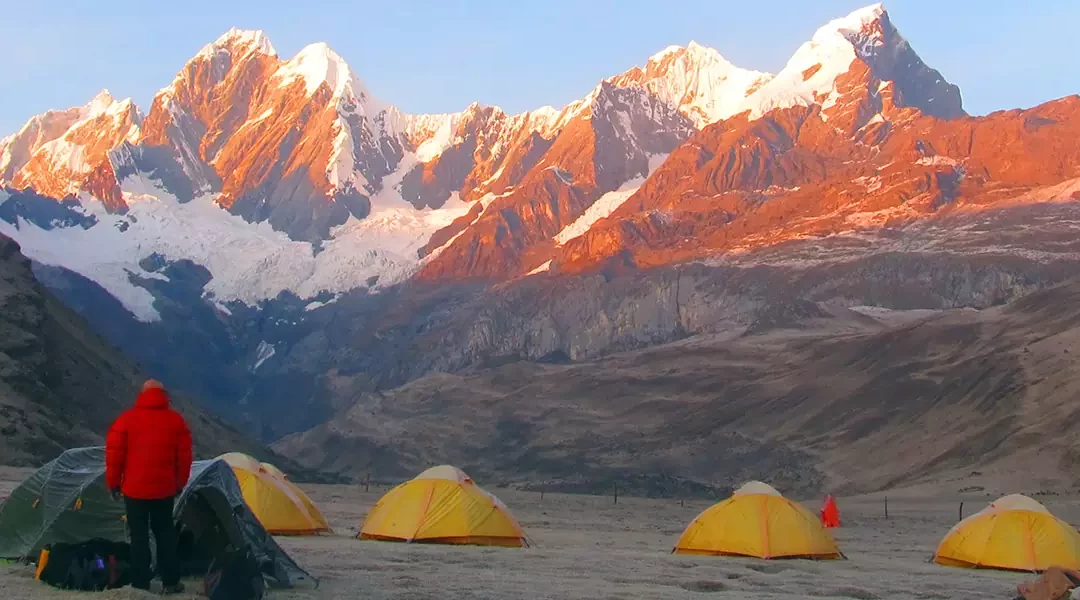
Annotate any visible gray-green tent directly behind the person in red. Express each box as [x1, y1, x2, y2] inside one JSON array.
[[0, 447, 316, 587]]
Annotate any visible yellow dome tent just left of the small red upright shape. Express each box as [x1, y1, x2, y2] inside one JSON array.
[[674, 481, 843, 559]]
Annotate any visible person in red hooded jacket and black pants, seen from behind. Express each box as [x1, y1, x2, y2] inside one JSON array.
[[105, 379, 191, 594]]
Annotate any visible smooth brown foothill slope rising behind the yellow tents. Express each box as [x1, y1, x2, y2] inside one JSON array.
[[275, 279, 1080, 497]]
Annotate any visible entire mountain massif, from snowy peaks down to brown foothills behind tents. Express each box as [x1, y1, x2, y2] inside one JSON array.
[[0, 4, 1080, 495]]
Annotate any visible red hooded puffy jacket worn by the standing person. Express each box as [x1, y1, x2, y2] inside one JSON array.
[[105, 387, 191, 500]]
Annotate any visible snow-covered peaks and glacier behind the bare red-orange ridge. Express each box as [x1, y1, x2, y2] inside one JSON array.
[[0, 4, 980, 321]]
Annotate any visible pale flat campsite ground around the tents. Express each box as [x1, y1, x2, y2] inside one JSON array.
[[0, 467, 1049, 600]]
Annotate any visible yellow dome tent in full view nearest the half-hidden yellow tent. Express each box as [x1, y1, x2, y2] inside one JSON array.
[[359, 465, 527, 547]]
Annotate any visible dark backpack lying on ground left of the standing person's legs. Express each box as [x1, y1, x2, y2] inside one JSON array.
[[38, 538, 131, 591]]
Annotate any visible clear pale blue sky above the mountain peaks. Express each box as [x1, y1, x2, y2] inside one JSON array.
[[0, 0, 1080, 135]]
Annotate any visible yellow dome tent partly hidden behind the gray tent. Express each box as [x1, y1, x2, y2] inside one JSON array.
[[220, 452, 330, 535]]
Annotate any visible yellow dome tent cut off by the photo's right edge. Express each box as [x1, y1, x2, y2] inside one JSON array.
[[934, 494, 1080, 571]]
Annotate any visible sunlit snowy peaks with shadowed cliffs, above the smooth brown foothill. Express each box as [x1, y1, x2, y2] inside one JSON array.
[[0, 5, 1080, 455]]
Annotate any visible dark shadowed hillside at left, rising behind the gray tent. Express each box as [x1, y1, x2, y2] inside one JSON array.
[[0, 232, 295, 470]]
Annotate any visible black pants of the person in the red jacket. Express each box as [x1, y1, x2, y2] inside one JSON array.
[[124, 496, 180, 589]]
